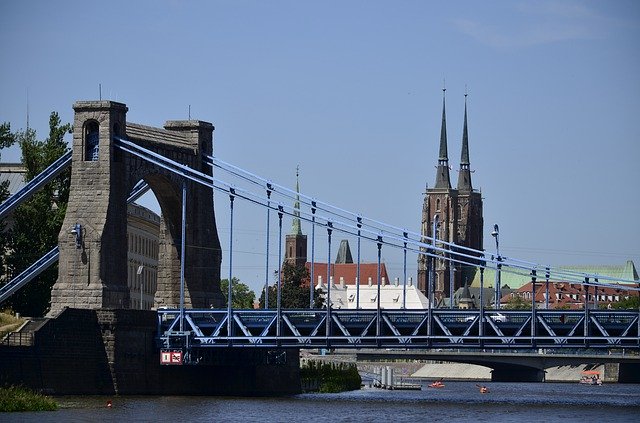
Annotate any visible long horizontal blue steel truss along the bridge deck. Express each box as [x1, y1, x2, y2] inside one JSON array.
[[158, 309, 640, 350]]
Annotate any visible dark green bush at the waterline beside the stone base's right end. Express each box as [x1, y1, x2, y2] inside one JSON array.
[[300, 360, 362, 393]]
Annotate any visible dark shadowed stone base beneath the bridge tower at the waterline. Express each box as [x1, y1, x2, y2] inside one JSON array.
[[0, 308, 301, 396]]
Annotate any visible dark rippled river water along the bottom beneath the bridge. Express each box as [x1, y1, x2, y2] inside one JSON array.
[[6, 382, 640, 423]]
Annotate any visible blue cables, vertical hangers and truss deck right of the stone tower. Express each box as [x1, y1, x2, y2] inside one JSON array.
[[6, 137, 640, 355]]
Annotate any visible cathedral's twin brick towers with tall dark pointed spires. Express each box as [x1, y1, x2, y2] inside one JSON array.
[[418, 89, 483, 305]]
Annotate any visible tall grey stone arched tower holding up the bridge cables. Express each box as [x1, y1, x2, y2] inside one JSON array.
[[49, 101, 224, 315]]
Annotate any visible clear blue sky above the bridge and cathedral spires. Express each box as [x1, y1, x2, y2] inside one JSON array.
[[0, 0, 640, 294]]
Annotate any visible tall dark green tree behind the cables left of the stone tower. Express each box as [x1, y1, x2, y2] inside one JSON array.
[[2, 112, 71, 317]]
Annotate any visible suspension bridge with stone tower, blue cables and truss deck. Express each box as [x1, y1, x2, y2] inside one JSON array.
[[0, 102, 640, 363]]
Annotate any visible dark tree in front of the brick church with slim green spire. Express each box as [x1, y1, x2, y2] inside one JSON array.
[[260, 262, 324, 308]]
